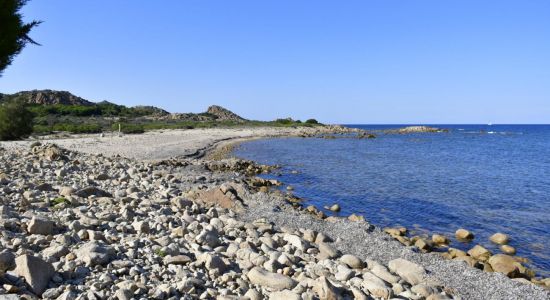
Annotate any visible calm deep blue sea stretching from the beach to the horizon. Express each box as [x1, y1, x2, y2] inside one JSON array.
[[236, 125, 550, 276]]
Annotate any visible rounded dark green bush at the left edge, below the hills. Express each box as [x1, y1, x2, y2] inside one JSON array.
[[0, 101, 33, 141]]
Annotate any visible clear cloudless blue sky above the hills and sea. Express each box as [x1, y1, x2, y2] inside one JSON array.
[[0, 0, 550, 123]]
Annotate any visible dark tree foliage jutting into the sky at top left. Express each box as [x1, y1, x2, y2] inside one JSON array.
[[0, 0, 41, 77]]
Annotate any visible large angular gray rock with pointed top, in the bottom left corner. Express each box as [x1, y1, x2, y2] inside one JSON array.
[[14, 254, 55, 295]]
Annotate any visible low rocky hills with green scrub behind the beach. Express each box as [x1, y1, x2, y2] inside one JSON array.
[[0, 90, 310, 134]]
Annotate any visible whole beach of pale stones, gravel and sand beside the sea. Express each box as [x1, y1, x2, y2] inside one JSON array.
[[0, 126, 550, 300]]
